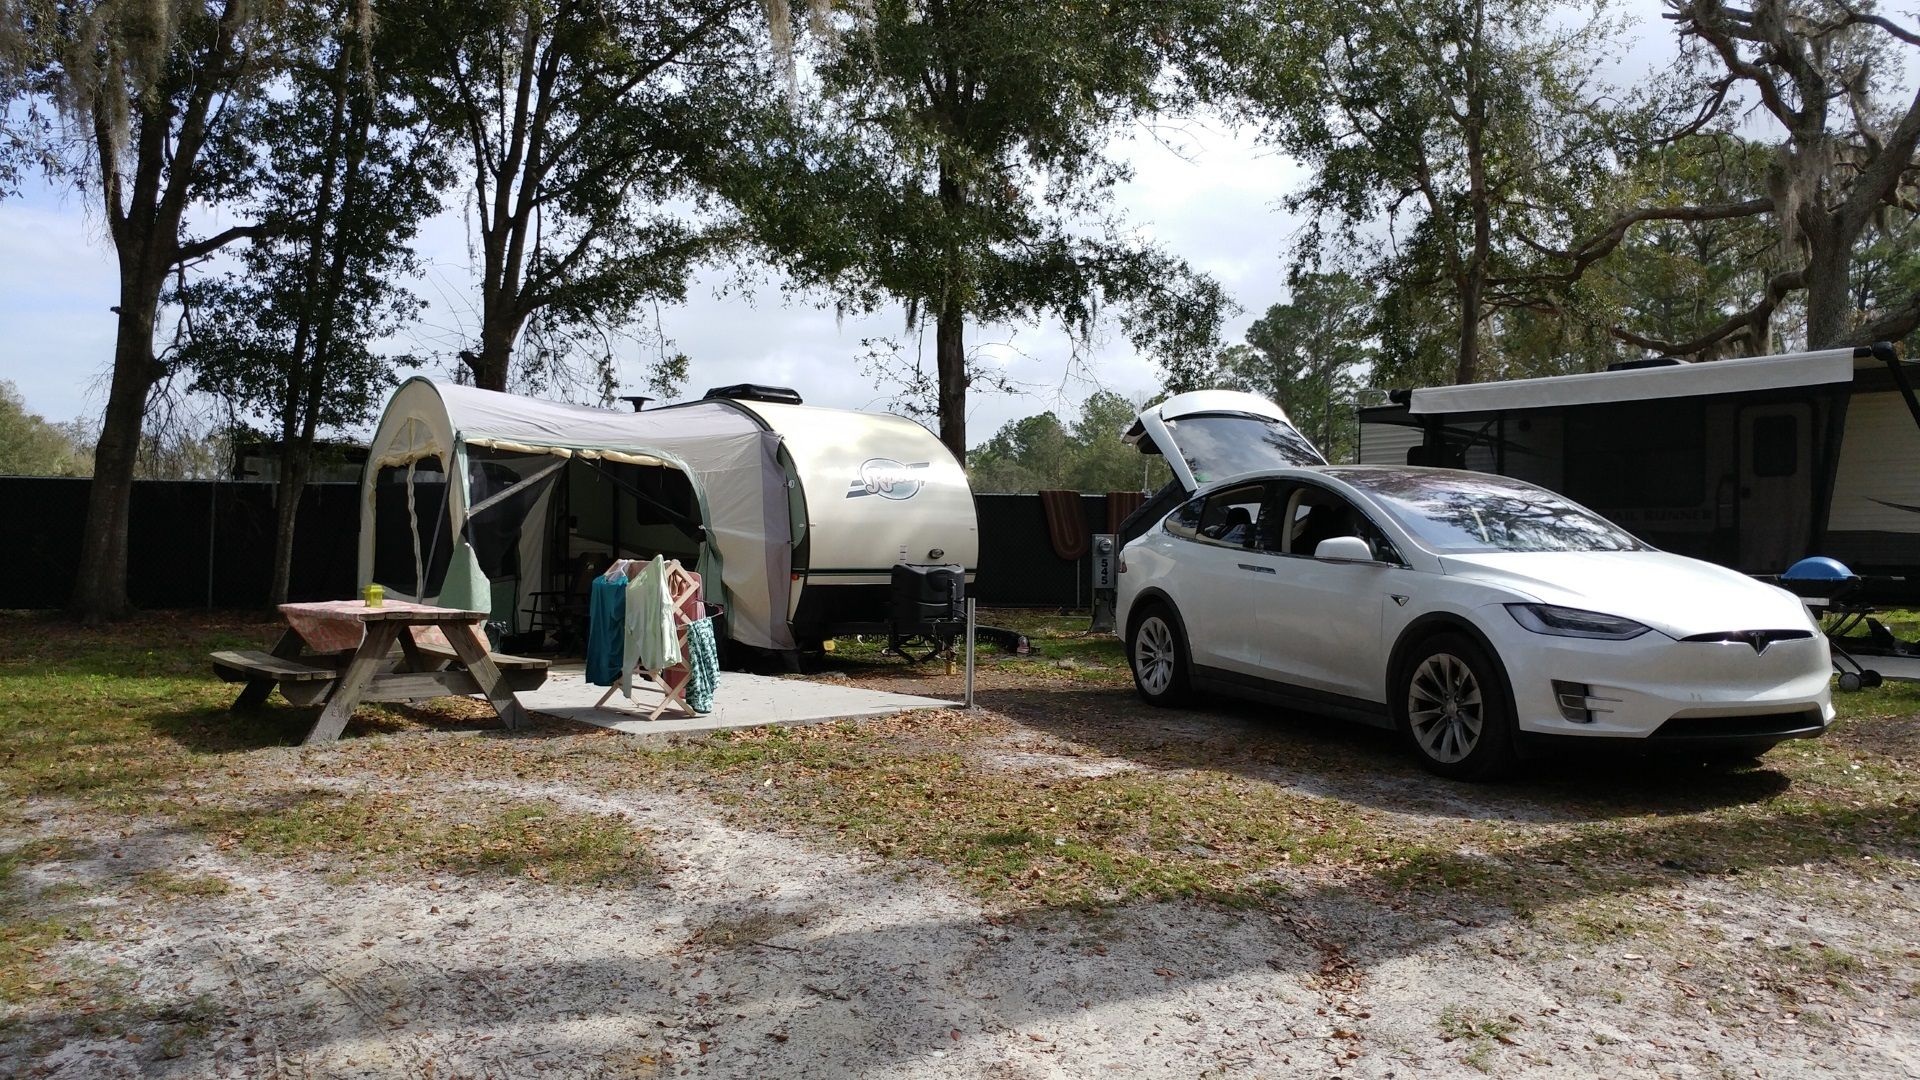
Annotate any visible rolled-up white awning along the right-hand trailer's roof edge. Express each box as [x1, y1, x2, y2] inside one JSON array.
[[1407, 348, 1872, 415]]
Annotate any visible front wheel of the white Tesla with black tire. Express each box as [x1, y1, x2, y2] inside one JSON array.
[[1388, 634, 1515, 780]]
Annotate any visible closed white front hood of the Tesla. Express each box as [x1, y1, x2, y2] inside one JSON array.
[[1440, 552, 1818, 638]]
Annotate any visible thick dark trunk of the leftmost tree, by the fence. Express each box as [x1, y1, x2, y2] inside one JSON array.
[[69, 276, 159, 625]]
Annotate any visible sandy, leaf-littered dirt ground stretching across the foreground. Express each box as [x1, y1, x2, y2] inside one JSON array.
[[0, 622, 1920, 1080]]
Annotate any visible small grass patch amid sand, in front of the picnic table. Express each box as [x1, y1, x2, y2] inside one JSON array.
[[196, 790, 659, 886]]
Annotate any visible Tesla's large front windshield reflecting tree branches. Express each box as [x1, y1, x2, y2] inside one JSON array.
[[1336, 469, 1649, 555]]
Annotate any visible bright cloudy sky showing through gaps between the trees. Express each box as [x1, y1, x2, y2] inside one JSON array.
[[0, 4, 1667, 446]]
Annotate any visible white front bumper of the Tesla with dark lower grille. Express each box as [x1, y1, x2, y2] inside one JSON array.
[[1480, 607, 1834, 748]]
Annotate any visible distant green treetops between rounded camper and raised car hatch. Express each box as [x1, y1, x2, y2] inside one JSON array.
[[968, 390, 1169, 492]]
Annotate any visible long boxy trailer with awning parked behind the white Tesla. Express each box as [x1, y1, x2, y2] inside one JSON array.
[[1359, 344, 1920, 603]]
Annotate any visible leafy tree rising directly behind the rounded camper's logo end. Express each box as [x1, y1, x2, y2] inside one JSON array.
[[730, 0, 1227, 454]]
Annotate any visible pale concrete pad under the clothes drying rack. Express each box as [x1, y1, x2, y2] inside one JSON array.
[[516, 665, 958, 736]]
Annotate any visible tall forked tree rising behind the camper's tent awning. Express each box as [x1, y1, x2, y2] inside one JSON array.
[[384, 0, 780, 398]]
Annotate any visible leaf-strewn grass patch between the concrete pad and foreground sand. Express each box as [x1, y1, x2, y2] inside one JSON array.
[[662, 713, 1400, 909]]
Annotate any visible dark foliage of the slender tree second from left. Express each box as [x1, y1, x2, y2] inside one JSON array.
[[173, 0, 445, 447]]
